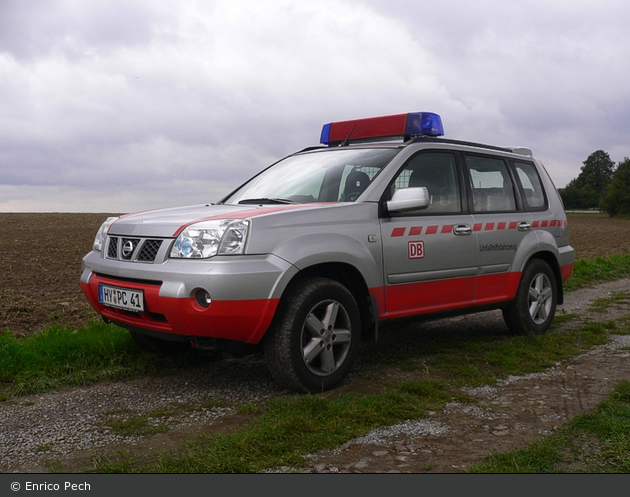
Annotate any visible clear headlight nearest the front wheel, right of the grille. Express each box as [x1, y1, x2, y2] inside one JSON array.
[[171, 219, 249, 259]]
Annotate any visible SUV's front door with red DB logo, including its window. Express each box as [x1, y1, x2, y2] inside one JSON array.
[[381, 151, 477, 318]]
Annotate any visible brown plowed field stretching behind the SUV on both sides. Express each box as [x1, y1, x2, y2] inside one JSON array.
[[0, 213, 630, 334]]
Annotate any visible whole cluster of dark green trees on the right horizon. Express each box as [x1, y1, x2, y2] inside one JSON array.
[[558, 150, 630, 217]]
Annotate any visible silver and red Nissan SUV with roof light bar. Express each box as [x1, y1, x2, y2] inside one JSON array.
[[81, 112, 574, 392]]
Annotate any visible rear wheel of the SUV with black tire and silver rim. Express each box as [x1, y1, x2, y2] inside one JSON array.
[[503, 259, 558, 335]]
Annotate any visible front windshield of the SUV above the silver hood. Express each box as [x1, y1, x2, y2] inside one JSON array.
[[222, 148, 399, 204]]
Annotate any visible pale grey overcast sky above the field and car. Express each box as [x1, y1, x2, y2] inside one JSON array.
[[0, 0, 630, 213]]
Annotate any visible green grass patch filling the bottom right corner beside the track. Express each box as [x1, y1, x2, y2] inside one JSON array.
[[469, 381, 630, 473]]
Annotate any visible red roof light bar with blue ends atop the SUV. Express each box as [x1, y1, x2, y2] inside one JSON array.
[[319, 112, 444, 145]]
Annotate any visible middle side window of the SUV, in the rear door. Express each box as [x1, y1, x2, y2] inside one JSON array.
[[466, 155, 516, 212]]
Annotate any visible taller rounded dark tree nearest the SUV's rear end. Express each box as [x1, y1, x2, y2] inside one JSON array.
[[560, 150, 615, 209]]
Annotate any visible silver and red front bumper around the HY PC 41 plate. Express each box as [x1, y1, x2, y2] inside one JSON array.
[[81, 252, 296, 344]]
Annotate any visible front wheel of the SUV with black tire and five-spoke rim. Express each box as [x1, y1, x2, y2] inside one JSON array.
[[264, 278, 361, 393]]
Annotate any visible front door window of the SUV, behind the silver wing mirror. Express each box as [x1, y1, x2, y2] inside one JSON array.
[[392, 152, 462, 214]]
